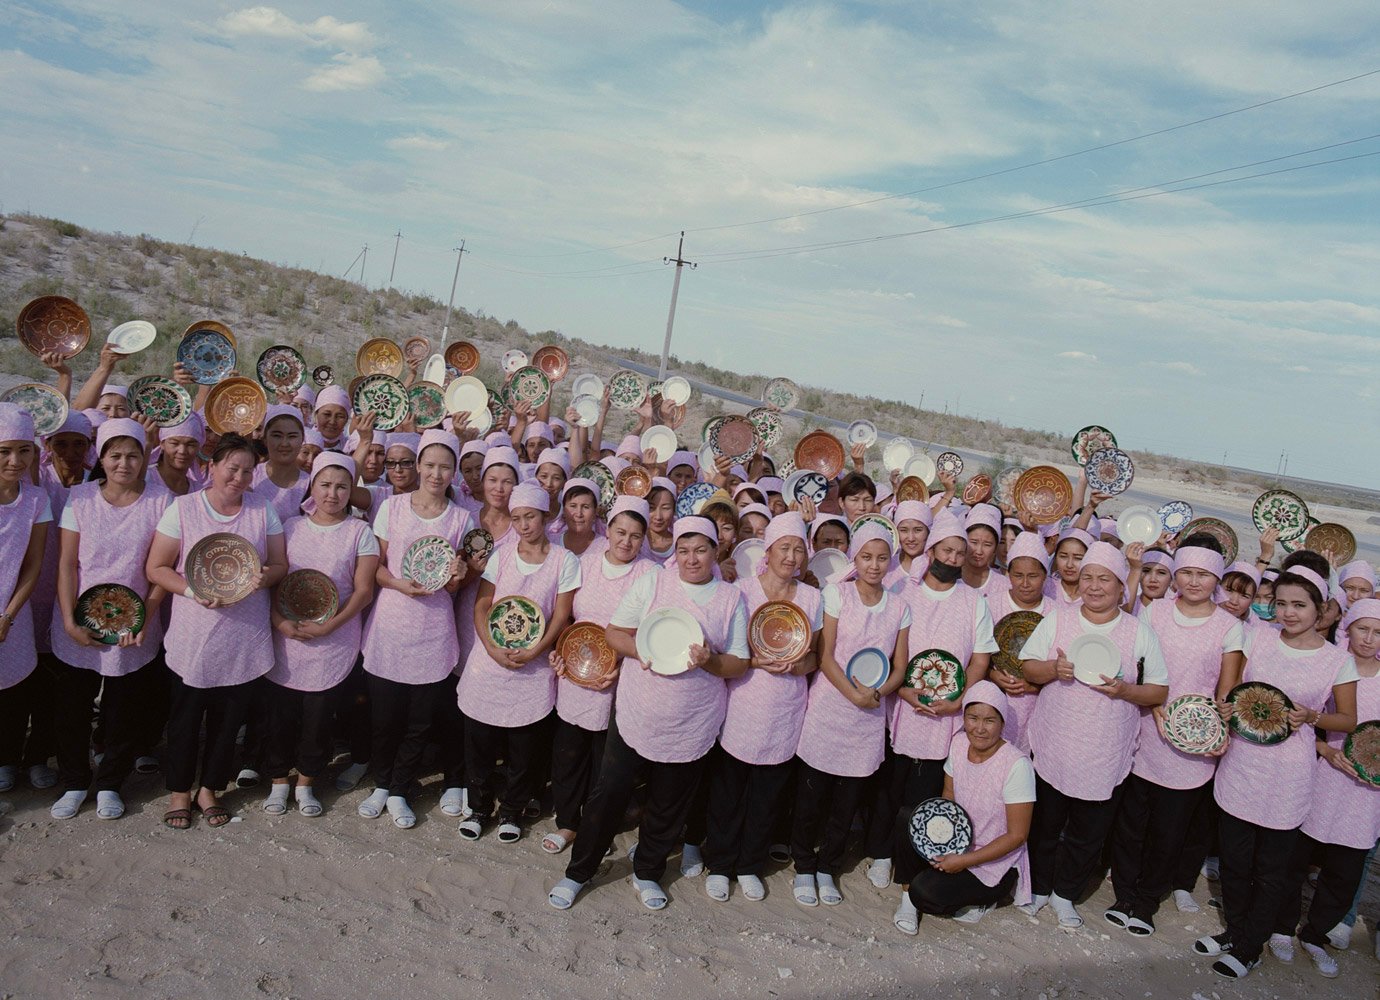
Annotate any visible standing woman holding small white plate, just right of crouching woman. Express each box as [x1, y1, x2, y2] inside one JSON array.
[[1021, 542, 1169, 930]]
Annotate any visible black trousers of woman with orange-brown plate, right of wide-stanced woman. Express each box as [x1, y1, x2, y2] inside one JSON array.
[[704, 746, 795, 877]]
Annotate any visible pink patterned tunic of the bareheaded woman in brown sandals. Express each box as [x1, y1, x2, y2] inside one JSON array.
[[164, 492, 273, 688]]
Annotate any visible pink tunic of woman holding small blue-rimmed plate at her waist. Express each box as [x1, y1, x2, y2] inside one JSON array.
[[796, 581, 905, 778]]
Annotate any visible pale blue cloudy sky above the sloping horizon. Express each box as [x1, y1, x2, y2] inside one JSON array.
[[8, 0, 1380, 487]]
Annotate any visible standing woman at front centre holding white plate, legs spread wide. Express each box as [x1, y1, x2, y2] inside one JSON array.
[[549, 517, 748, 910]]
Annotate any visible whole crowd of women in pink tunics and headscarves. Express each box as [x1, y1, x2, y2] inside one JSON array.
[[0, 337, 1380, 978]]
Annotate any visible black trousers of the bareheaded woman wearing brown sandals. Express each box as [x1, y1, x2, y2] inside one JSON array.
[[163, 673, 254, 792]]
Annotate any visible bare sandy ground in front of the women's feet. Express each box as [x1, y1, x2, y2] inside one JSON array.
[[0, 755, 1380, 1000]]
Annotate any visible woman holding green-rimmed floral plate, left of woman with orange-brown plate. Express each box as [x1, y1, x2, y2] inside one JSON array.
[[455, 483, 580, 844]]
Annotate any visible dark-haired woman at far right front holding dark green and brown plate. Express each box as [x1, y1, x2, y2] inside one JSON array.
[[1194, 565, 1357, 979]]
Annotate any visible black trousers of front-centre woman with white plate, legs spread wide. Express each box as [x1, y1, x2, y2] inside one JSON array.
[[566, 719, 705, 883]]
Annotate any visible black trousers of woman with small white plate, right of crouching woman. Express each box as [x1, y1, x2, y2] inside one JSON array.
[[1029, 771, 1121, 902]]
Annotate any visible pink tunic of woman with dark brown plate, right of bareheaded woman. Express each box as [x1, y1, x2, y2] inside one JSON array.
[[268, 516, 373, 691]]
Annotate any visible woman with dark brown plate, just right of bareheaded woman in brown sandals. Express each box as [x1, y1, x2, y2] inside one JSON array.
[[264, 451, 378, 817]]
